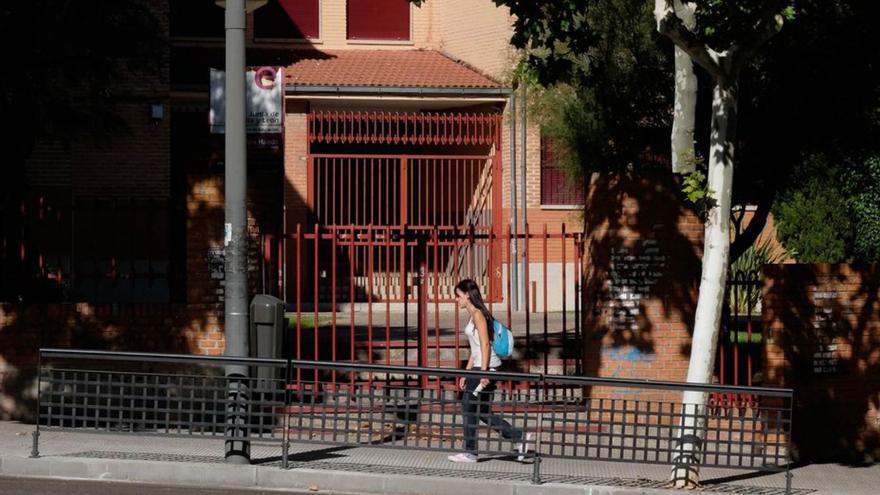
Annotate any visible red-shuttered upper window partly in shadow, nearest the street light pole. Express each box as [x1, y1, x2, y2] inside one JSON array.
[[254, 0, 321, 40]]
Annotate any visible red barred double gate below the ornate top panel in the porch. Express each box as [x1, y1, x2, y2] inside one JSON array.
[[311, 155, 500, 302]]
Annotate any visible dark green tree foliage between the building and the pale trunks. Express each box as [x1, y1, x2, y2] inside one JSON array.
[[514, 0, 672, 180]]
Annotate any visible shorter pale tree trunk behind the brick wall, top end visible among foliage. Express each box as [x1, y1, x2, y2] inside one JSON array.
[[672, 0, 697, 174]]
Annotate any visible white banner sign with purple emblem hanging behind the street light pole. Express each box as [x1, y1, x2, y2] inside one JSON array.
[[208, 67, 284, 134]]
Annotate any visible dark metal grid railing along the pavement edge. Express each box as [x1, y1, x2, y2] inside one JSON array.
[[33, 349, 793, 493]]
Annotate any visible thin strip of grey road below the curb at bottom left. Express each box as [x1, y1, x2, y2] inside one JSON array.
[[0, 476, 332, 495]]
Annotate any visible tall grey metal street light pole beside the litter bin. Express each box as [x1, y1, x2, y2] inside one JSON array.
[[223, 0, 251, 464]]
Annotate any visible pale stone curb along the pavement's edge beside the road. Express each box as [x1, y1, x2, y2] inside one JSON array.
[[0, 455, 684, 495]]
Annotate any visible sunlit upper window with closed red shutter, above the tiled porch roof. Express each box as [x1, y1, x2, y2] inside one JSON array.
[[347, 0, 410, 41]]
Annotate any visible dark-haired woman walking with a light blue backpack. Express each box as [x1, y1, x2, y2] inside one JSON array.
[[448, 279, 531, 462]]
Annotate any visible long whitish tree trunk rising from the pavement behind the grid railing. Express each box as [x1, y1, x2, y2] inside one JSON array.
[[671, 79, 737, 488]]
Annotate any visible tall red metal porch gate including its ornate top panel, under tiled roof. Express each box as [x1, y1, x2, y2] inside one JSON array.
[[308, 112, 501, 303]]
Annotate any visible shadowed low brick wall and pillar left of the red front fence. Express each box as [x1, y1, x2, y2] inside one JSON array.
[[0, 167, 281, 419]]
